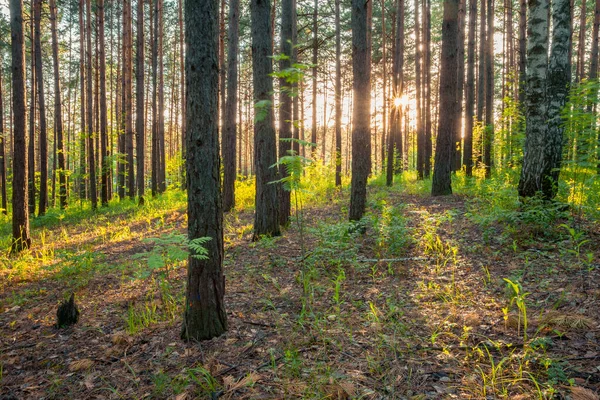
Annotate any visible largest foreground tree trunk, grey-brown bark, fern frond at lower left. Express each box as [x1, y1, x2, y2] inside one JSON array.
[[181, 0, 227, 340]]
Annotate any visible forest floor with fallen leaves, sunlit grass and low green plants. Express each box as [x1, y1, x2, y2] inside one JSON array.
[[0, 176, 600, 400]]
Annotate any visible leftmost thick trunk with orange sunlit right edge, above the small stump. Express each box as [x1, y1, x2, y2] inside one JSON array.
[[9, 0, 31, 253]]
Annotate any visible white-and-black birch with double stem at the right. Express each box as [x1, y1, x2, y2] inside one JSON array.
[[519, 0, 571, 200]]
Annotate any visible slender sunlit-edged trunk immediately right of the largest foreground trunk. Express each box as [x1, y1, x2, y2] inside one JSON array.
[[223, 0, 242, 212]]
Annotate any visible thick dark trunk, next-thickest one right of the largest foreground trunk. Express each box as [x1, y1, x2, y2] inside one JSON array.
[[250, 0, 280, 240]]
